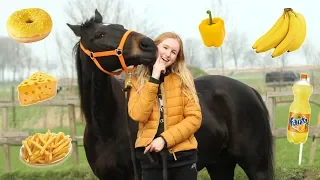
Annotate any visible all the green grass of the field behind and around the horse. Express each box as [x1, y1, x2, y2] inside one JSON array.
[[0, 70, 320, 180]]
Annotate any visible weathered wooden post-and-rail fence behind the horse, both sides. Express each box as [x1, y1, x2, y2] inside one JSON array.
[[0, 90, 320, 172]]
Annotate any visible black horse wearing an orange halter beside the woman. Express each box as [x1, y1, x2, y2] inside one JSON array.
[[68, 10, 274, 180]]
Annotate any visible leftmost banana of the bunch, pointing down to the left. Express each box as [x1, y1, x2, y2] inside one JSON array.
[[256, 11, 289, 53]]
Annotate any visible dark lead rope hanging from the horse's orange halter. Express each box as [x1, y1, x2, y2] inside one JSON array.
[[123, 72, 139, 180]]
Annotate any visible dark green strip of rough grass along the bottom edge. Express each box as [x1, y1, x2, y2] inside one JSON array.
[[0, 168, 320, 180]]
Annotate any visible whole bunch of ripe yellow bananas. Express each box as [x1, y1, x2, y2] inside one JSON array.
[[252, 8, 307, 58]]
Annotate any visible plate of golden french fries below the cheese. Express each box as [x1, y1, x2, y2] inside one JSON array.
[[21, 130, 71, 165]]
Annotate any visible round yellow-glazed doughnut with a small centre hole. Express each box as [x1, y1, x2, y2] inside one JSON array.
[[7, 8, 53, 43]]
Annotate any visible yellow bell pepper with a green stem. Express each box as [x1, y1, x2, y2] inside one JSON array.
[[199, 10, 225, 48]]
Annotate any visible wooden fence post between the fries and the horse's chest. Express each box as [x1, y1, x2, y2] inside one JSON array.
[[68, 104, 79, 164]]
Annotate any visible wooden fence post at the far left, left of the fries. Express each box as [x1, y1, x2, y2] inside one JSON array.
[[2, 107, 11, 172]]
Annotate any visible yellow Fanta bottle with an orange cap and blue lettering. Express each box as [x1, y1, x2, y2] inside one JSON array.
[[287, 73, 313, 144]]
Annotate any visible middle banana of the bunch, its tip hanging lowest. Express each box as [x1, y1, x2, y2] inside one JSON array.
[[271, 11, 300, 58]]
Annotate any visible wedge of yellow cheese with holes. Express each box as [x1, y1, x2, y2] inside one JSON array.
[[17, 72, 57, 106]]
